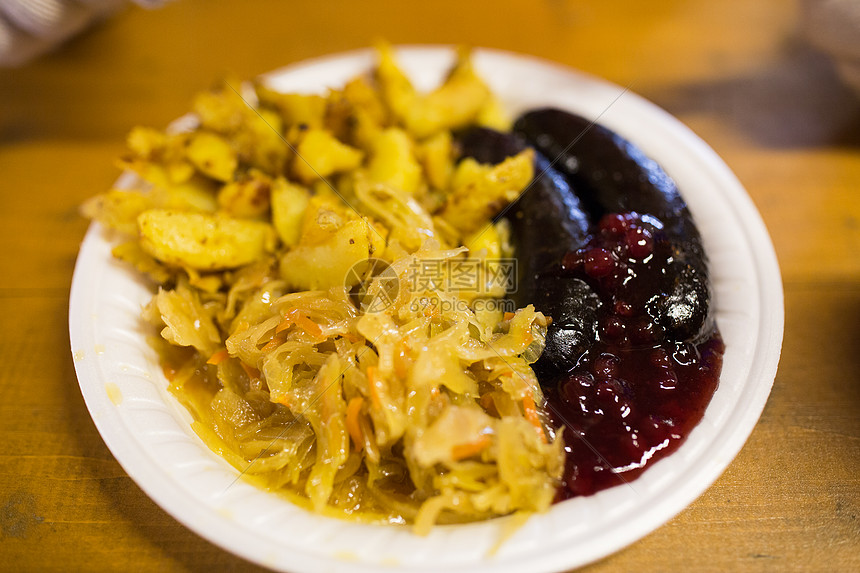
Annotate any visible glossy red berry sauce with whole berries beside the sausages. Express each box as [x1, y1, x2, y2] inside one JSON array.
[[546, 213, 724, 500]]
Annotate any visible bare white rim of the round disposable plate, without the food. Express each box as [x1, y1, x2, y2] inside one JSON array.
[[69, 47, 783, 573]]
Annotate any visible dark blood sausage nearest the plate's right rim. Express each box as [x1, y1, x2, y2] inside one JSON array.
[[514, 108, 713, 341]]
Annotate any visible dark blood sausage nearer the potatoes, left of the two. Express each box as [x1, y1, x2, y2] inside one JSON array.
[[458, 128, 600, 381]]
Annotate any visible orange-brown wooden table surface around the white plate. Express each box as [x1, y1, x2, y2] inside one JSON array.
[[0, 0, 860, 572]]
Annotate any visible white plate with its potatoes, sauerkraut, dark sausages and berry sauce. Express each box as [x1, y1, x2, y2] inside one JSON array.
[[69, 45, 783, 572]]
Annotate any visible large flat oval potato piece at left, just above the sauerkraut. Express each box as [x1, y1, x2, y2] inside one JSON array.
[[137, 209, 275, 271]]
